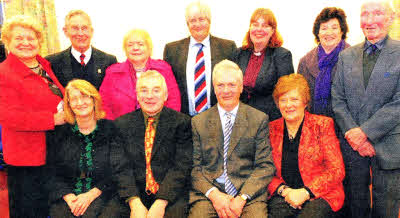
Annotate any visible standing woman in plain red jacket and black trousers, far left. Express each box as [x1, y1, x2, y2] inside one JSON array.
[[0, 16, 65, 217]]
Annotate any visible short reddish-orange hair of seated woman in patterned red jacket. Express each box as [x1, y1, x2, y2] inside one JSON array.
[[272, 73, 311, 106]]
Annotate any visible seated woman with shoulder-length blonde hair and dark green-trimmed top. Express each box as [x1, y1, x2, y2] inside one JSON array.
[[47, 80, 130, 218]]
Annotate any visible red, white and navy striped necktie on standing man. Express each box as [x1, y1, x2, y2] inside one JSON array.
[[194, 43, 208, 113]]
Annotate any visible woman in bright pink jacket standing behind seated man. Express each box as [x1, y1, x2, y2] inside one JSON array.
[[100, 29, 181, 120]]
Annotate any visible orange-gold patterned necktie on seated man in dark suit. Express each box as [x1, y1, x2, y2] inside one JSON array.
[[144, 117, 160, 195]]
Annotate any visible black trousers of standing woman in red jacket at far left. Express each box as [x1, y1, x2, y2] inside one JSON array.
[[7, 166, 48, 218]]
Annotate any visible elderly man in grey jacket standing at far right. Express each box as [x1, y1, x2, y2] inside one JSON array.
[[332, 1, 400, 218]]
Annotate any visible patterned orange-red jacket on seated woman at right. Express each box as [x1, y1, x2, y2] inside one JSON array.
[[268, 112, 345, 211]]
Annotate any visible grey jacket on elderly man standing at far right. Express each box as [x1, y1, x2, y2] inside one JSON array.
[[332, 38, 400, 169]]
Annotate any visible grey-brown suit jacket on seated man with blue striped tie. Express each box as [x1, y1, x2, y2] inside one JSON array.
[[190, 103, 275, 203]]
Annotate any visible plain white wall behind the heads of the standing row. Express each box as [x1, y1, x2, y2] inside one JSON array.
[[55, 0, 363, 70]]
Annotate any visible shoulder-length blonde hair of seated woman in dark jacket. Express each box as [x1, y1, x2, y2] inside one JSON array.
[[64, 79, 106, 124]]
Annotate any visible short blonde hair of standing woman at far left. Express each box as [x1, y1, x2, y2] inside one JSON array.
[[1, 15, 43, 47]]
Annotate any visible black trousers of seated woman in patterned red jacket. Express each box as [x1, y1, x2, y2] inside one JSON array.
[[268, 195, 335, 218]]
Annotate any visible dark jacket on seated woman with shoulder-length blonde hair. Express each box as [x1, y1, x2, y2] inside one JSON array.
[[46, 120, 132, 202]]
